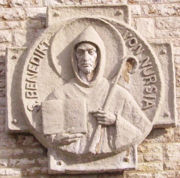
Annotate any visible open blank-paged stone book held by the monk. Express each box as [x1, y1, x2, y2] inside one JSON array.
[[42, 98, 87, 134]]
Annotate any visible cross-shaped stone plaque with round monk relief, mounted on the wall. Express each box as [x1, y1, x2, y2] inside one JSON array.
[[7, 6, 176, 174]]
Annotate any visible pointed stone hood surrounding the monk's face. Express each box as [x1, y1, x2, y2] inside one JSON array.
[[71, 26, 105, 87]]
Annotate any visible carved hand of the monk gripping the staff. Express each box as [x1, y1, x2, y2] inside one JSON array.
[[91, 110, 116, 126]]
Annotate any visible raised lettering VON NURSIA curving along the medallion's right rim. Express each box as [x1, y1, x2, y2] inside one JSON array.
[[123, 30, 157, 110]]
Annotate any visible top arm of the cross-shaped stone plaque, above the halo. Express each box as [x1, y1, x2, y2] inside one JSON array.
[[47, 5, 130, 26]]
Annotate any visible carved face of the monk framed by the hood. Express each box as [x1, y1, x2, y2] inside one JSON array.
[[75, 43, 97, 74]]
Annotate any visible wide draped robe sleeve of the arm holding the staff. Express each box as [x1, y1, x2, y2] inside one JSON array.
[[115, 90, 152, 151]]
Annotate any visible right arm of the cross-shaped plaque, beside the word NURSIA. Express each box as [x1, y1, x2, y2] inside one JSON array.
[[152, 42, 177, 127]]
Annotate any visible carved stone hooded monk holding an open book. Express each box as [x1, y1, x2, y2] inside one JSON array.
[[42, 26, 151, 155]]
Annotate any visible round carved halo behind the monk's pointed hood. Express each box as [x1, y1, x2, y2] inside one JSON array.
[[50, 17, 125, 81]]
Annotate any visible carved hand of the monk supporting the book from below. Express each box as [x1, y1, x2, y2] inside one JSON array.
[[54, 133, 83, 145]]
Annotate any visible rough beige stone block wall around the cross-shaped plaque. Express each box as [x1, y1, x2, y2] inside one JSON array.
[[0, 0, 180, 178]]
